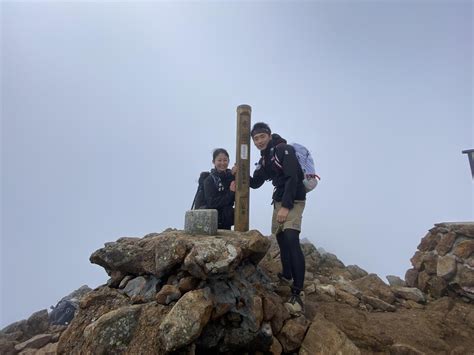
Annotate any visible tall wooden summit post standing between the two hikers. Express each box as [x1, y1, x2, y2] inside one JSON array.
[[234, 105, 252, 232]]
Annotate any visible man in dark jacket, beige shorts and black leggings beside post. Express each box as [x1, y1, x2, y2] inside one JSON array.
[[250, 122, 306, 314]]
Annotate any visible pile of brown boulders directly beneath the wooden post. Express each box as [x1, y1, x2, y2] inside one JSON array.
[[58, 230, 309, 354]]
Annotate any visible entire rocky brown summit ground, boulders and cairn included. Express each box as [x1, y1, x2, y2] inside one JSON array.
[[0, 223, 474, 354]]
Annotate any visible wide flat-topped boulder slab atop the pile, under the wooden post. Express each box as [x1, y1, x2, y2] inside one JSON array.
[[90, 230, 270, 279]]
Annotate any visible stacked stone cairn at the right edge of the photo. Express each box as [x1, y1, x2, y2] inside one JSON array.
[[405, 223, 474, 302]]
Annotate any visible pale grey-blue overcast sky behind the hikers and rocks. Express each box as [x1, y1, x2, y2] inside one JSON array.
[[0, 1, 474, 327]]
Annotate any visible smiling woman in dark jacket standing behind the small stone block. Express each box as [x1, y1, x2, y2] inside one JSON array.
[[204, 148, 235, 229]]
